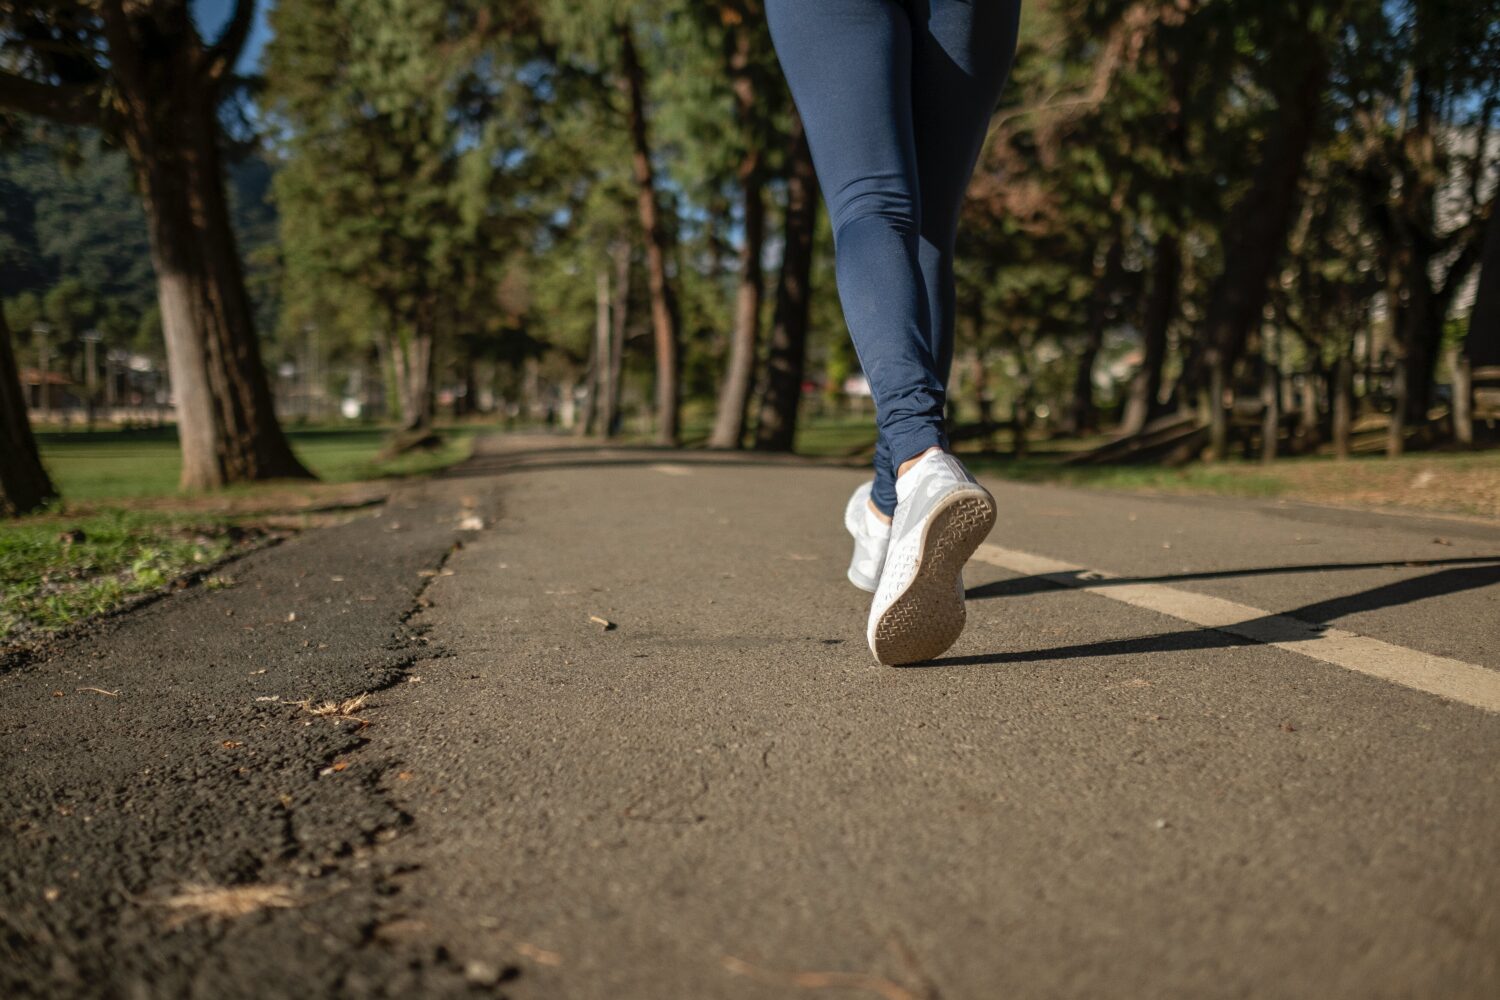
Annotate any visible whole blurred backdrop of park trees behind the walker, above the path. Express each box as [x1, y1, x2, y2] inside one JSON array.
[[0, 0, 1500, 509]]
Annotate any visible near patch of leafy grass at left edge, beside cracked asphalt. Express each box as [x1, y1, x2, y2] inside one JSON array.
[[0, 510, 245, 642]]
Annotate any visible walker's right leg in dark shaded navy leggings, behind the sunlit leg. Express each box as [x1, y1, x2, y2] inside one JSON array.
[[909, 0, 1022, 388]]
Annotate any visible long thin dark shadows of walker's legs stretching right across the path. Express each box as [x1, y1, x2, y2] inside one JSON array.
[[911, 556, 1500, 667]]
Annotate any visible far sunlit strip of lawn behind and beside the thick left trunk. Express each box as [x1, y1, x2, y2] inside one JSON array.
[[38, 426, 476, 501]]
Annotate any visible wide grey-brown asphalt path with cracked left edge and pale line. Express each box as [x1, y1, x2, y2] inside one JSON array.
[[0, 439, 1500, 1000]]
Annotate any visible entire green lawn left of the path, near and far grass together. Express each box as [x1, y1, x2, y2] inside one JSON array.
[[0, 426, 477, 652]]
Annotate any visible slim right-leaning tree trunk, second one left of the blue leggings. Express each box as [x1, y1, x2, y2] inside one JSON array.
[[708, 22, 765, 448]]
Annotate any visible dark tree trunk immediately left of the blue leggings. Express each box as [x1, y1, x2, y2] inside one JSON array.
[[755, 112, 818, 451]]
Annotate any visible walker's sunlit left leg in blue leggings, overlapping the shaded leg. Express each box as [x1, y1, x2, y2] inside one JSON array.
[[767, 0, 945, 514]]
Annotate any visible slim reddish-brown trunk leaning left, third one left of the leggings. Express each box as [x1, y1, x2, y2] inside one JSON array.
[[615, 21, 681, 447]]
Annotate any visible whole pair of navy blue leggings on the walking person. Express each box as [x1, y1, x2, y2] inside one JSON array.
[[765, 0, 1020, 514]]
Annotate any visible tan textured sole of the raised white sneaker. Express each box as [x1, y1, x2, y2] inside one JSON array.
[[870, 490, 995, 666]]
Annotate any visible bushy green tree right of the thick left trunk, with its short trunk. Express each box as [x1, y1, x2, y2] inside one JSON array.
[[267, 0, 546, 444]]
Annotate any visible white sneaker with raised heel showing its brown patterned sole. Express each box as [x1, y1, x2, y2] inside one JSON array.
[[866, 451, 995, 666]]
